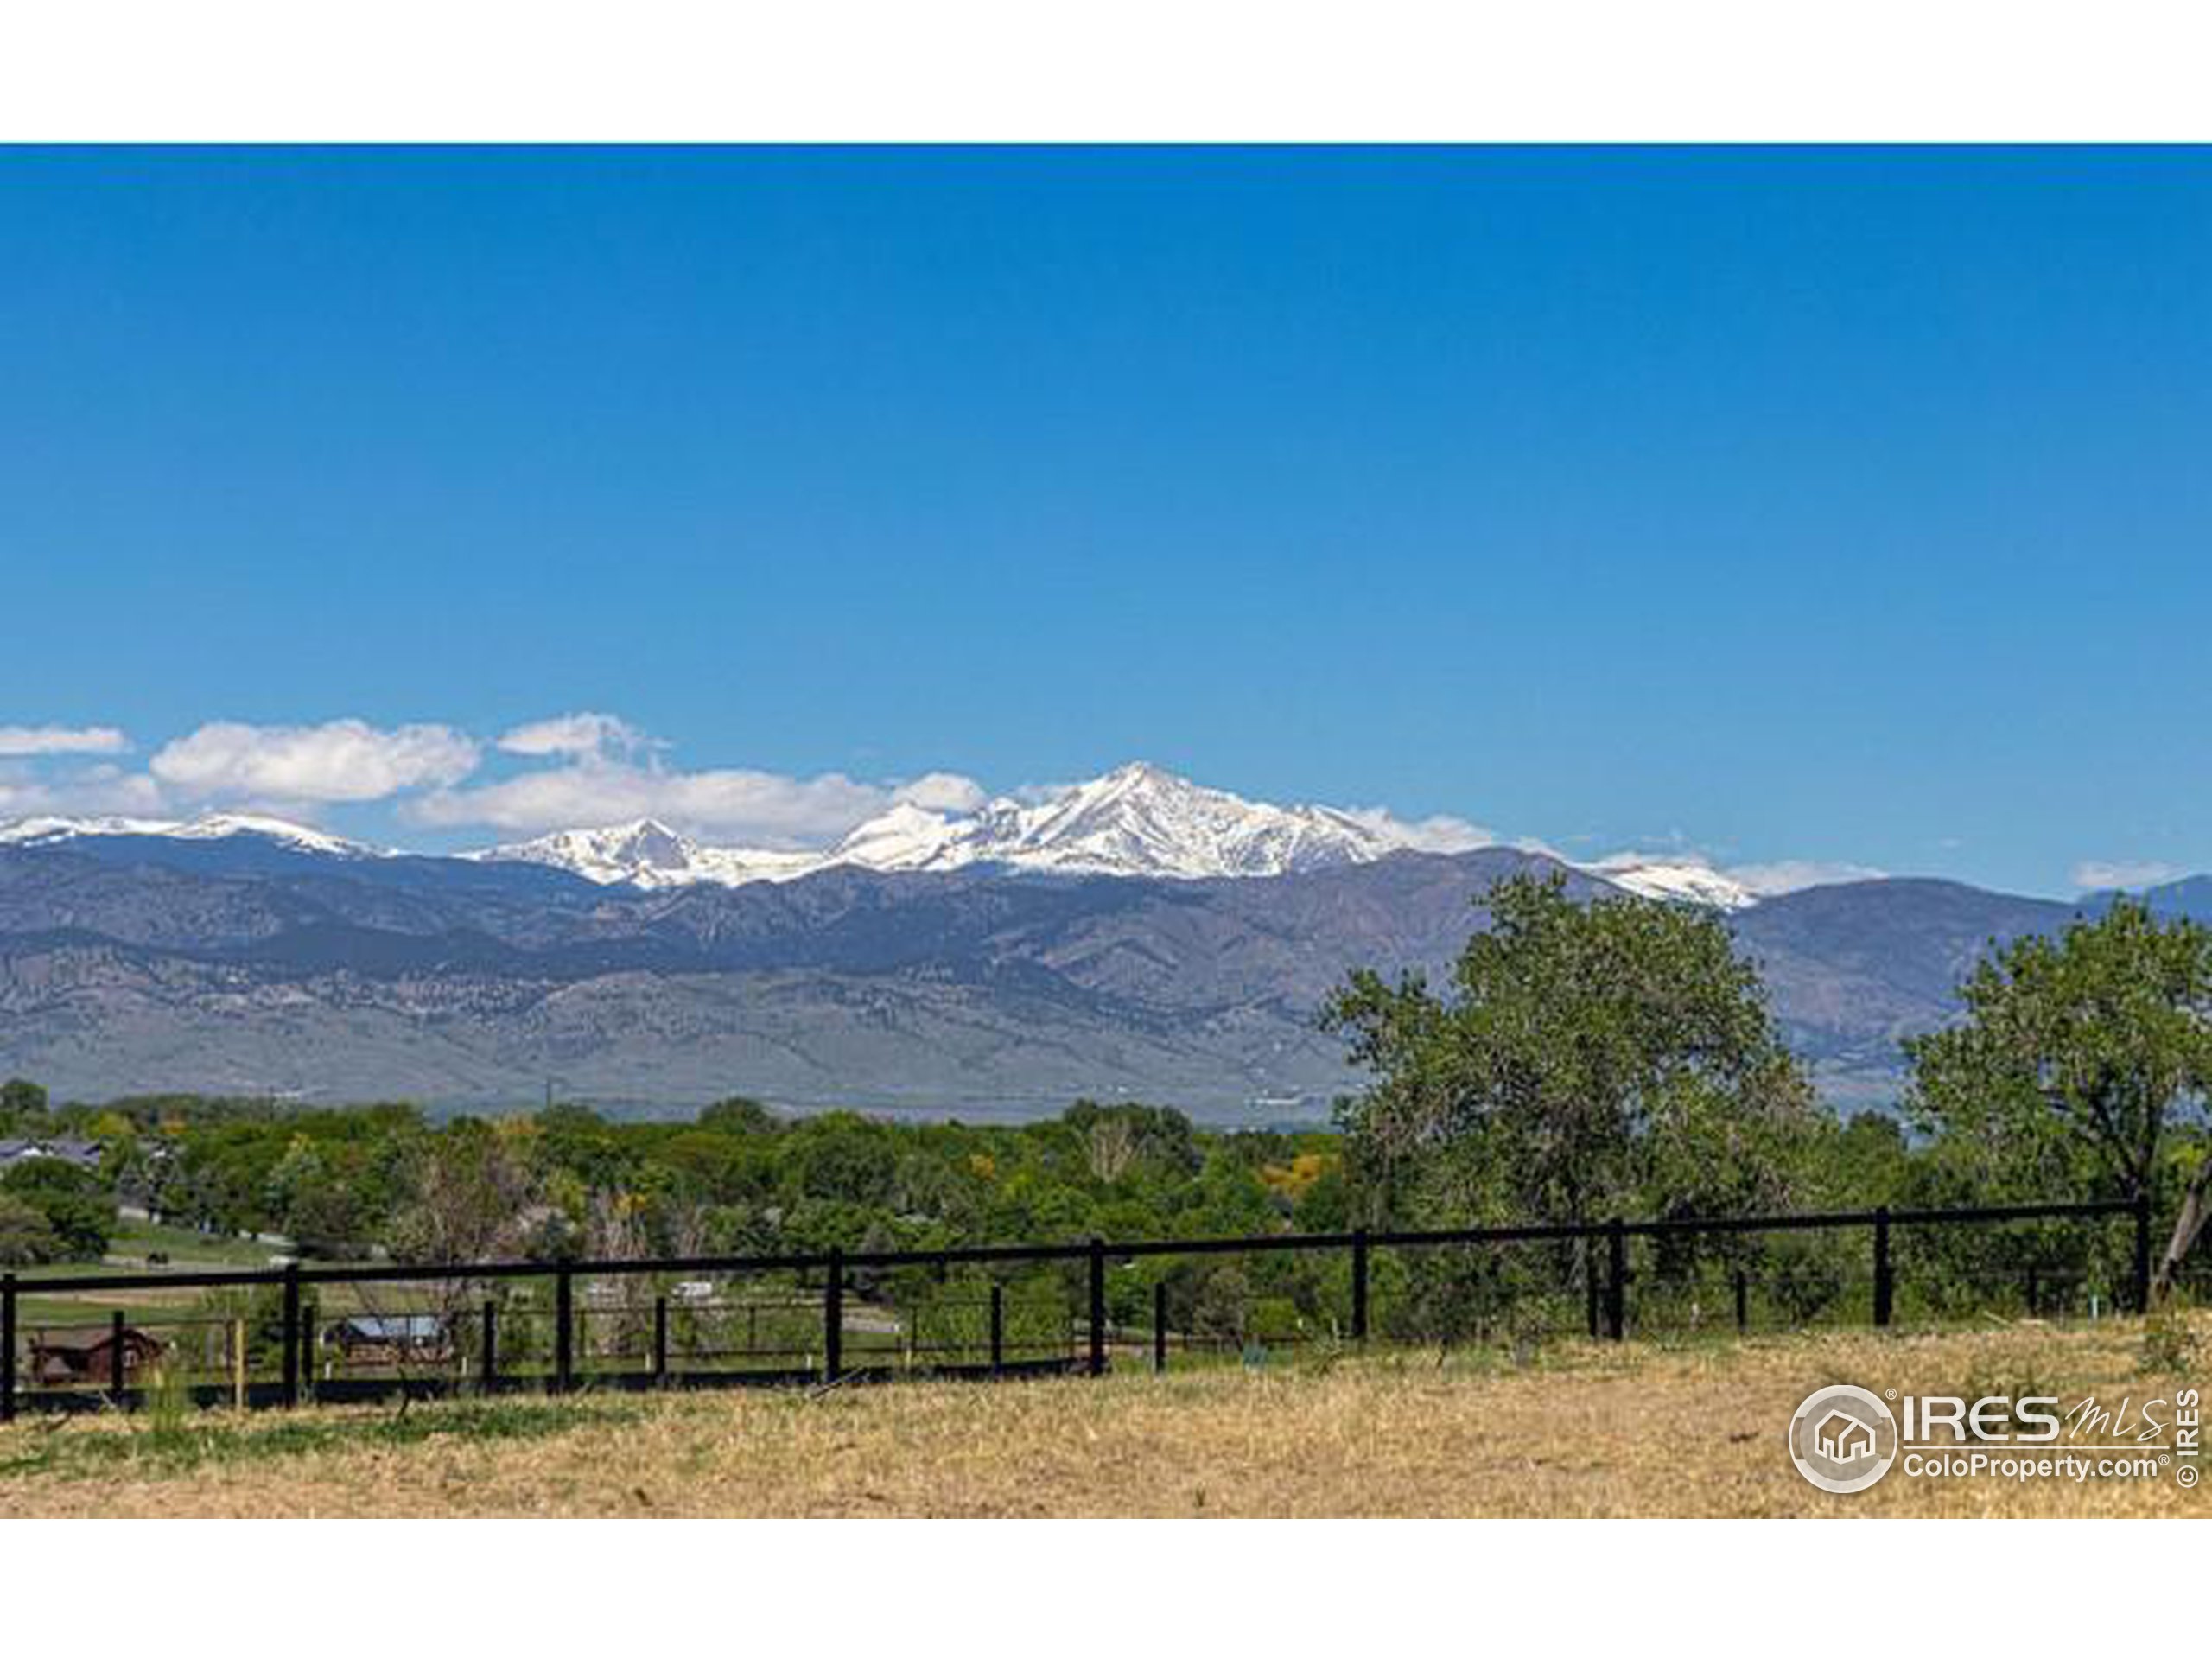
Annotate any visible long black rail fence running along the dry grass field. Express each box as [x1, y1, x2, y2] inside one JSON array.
[[0, 1199, 2150, 1421]]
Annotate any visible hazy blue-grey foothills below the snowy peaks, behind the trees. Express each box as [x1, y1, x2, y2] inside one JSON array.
[[0, 836, 2158, 1119]]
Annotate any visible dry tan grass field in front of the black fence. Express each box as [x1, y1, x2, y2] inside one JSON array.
[[0, 1320, 2212, 1516]]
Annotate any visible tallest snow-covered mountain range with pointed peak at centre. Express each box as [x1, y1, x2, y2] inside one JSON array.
[[469, 761, 1414, 887]]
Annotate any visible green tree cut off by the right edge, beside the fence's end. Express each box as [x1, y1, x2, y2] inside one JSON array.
[[1904, 900, 2212, 1292]]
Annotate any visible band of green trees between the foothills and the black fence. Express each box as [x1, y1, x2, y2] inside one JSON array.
[[0, 876, 2212, 1332]]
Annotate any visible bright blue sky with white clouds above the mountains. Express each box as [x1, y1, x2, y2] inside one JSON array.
[[0, 150, 2212, 892]]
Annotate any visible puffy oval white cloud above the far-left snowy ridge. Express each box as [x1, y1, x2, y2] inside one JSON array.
[[153, 719, 478, 803]]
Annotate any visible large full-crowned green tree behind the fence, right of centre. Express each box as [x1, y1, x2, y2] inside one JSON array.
[[1325, 874, 1821, 1225]]
